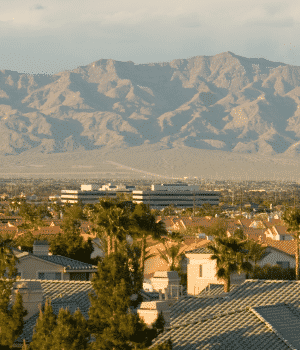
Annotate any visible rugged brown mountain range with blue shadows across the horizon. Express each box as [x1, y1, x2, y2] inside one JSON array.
[[0, 51, 300, 180]]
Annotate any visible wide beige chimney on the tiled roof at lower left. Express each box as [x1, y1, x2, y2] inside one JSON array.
[[12, 280, 43, 321]]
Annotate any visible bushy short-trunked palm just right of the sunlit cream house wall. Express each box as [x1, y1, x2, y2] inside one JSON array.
[[207, 237, 252, 293]]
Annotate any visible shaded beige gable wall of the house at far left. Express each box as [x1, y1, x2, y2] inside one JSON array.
[[16, 256, 70, 280]]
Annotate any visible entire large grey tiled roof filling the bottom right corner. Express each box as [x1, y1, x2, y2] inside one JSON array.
[[149, 280, 300, 350]]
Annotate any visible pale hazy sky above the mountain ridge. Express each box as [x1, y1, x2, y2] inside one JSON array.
[[0, 0, 300, 74]]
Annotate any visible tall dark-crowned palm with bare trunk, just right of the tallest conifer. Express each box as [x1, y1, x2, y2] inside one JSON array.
[[132, 203, 168, 273]]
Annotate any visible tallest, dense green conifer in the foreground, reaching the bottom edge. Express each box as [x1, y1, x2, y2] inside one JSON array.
[[88, 253, 157, 350]]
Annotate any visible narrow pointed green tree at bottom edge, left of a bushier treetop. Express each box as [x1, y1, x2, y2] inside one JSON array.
[[30, 300, 57, 350]]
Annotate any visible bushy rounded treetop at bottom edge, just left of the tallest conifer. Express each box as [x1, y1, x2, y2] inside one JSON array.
[[51, 308, 90, 350]]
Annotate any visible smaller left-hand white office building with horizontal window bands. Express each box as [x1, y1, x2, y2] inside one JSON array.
[[60, 185, 117, 204]]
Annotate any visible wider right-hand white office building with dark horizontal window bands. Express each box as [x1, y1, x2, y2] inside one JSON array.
[[132, 183, 220, 209]]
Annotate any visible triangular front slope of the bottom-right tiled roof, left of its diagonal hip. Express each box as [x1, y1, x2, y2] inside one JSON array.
[[150, 308, 291, 350]]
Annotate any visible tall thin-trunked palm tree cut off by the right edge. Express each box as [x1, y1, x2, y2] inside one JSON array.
[[282, 208, 300, 280]]
